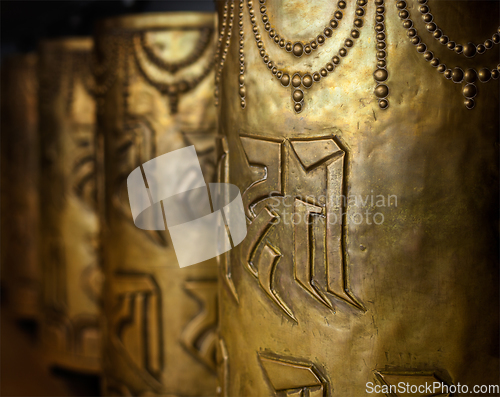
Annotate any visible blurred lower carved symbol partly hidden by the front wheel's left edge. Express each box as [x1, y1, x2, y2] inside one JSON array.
[[181, 280, 217, 371]]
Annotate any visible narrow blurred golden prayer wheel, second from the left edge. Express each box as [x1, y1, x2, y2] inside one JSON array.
[[39, 38, 102, 372]]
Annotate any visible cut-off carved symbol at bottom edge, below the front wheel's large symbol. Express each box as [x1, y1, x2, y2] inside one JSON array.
[[259, 354, 327, 397]]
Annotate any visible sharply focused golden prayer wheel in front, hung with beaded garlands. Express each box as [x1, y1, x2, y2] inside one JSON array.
[[216, 0, 500, 397]]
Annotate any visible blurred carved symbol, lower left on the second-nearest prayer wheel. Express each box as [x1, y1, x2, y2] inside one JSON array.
[[111, 273, 164, 387]]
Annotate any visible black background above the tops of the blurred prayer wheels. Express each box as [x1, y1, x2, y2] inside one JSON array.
[[0, 0, 215, 57]]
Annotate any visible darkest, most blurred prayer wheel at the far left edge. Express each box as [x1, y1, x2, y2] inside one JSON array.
[[1, 54, 40, 320]]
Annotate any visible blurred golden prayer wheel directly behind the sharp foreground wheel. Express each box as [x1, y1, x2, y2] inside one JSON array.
[[93, 13, 217, 396]]
